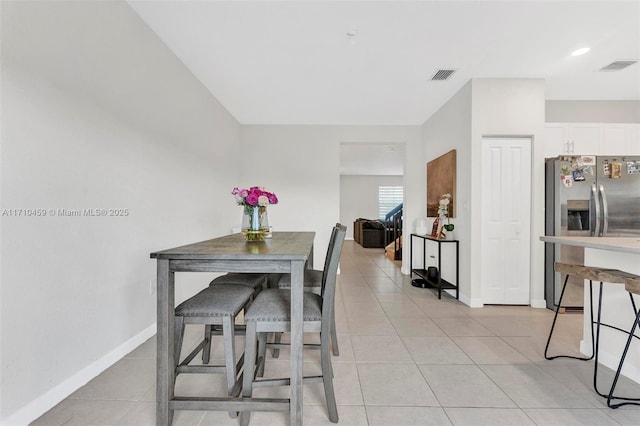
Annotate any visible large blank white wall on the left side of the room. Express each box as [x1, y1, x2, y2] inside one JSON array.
[[0, 2, 239, 425]]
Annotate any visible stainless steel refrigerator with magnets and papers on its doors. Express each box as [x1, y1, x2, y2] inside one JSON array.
[[545, 155, 640, 310]]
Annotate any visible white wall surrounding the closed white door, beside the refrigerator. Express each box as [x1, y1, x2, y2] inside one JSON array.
[[422, 79, 544, 307]]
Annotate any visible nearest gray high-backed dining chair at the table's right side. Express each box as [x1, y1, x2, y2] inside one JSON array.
[[240, 224, 347, 426]]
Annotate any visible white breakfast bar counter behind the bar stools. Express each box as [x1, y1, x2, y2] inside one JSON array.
[[540, 236, 640, 383]]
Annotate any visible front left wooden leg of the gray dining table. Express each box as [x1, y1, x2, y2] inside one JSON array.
[[156, 259, 175, 426]]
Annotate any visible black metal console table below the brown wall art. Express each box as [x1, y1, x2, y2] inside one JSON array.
[[409, 234, 460, 299]]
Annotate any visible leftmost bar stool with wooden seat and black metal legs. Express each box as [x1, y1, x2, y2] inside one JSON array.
[[544, 262, 638, 398]]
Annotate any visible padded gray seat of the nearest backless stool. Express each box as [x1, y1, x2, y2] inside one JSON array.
[[175, 284, 253, 317]]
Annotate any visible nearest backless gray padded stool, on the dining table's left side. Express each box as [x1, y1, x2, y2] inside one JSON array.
[[174, 284, 254, 410]]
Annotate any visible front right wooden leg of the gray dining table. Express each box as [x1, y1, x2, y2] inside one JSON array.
[[290, 261, 304, 426]]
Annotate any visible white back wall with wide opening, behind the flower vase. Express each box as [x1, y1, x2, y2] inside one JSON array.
[[238, 125, 425, 273]]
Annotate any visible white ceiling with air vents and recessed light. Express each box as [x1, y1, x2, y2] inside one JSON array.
[[129, 0, 640, 125]]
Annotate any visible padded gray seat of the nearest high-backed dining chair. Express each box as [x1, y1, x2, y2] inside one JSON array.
[[244, 288, 322, 322]]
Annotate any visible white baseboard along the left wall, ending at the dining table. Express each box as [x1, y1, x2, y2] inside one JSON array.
[[0, 324, 156, 426]]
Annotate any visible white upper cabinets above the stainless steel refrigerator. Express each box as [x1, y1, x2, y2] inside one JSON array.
[[544, 123, 640, 157]]
